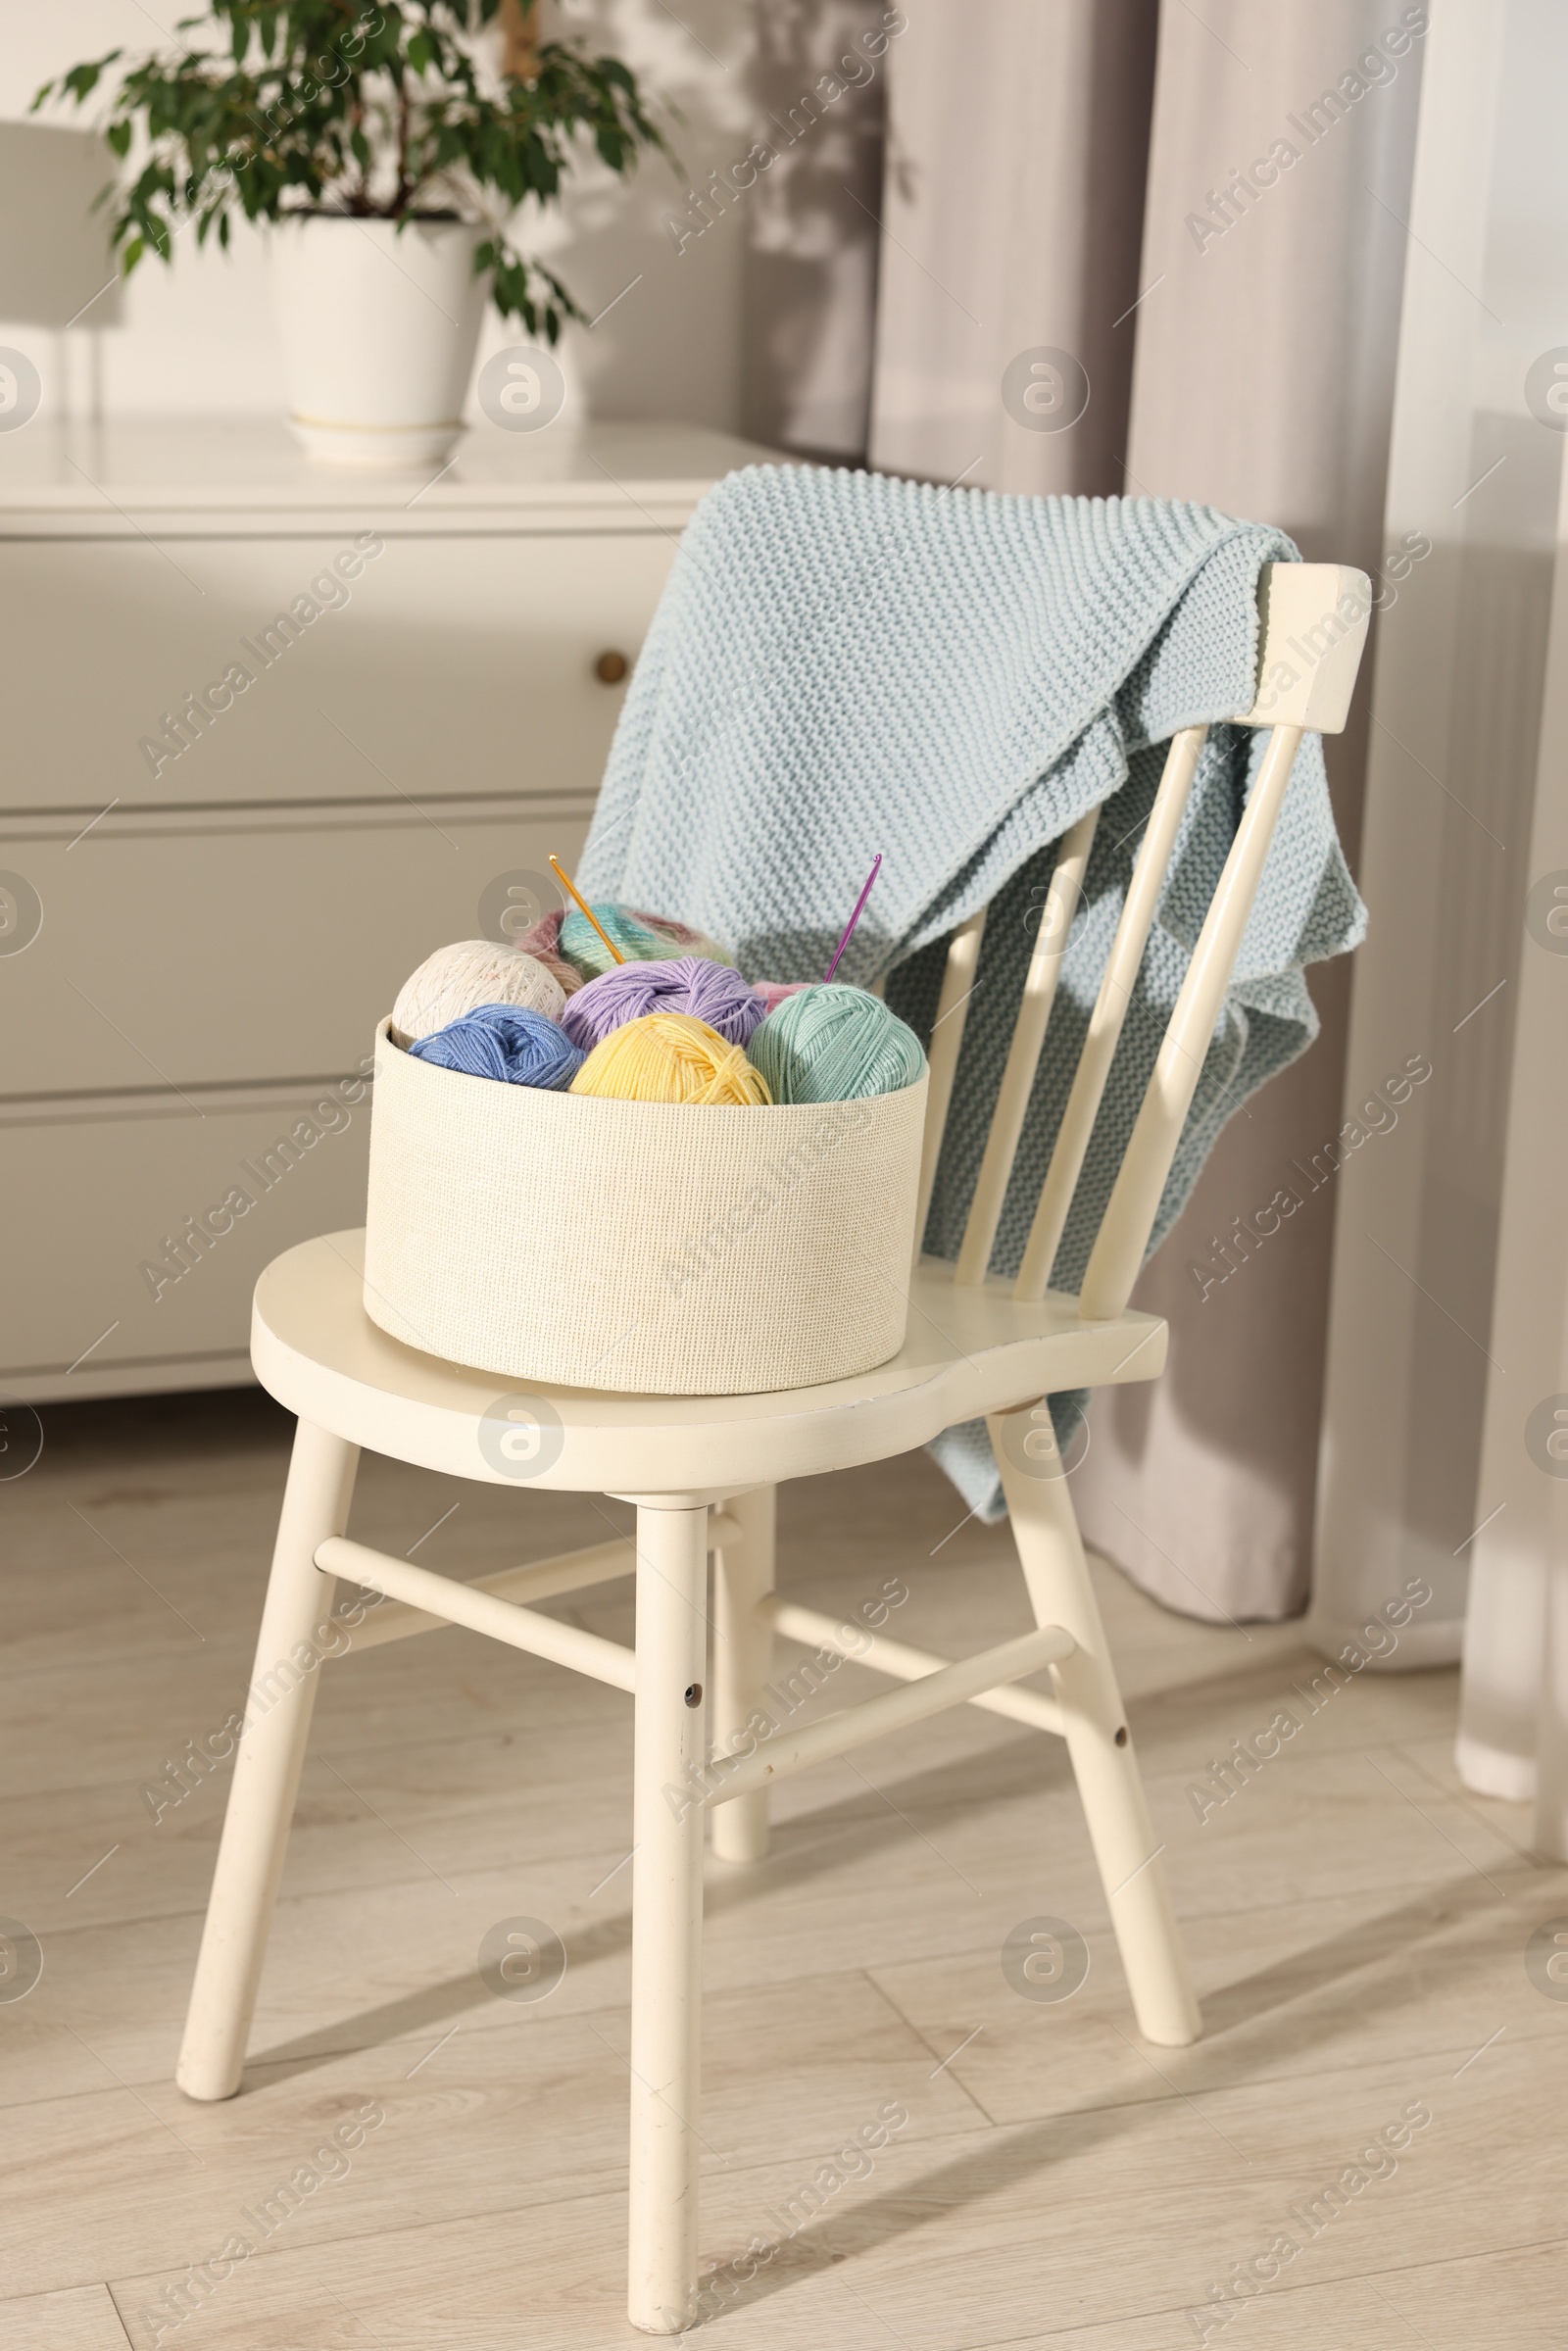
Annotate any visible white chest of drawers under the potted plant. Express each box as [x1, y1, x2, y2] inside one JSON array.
[[0, 423, 761, 1401]]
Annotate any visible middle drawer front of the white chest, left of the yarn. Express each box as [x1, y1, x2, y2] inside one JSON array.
[[0, 795, 590, 1098]]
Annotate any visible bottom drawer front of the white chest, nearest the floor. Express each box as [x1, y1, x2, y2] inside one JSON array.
[[0, 1077, 369, 1401]]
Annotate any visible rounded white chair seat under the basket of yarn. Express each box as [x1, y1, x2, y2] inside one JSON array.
[[252, 1232, 1166, 1495]]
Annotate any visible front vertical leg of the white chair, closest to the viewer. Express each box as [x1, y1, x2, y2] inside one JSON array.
[[627, 1502, 708, 2334]]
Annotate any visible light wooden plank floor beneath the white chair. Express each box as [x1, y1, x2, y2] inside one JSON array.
[[0, 1395, 1568, 2351]]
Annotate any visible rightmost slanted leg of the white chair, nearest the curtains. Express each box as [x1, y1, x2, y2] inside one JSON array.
[[987, 1406, 1201, 2048]]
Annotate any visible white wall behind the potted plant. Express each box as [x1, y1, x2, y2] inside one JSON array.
[[0, 0, 753, 430]]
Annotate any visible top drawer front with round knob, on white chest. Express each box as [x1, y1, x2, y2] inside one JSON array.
[[0, 531, 674, 817]]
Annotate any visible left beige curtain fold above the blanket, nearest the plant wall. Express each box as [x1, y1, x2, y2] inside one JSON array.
[[870, 0, 1156, 491]]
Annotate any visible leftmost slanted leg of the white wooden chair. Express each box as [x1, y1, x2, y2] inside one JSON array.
[[174, 1420, 360, 2097]]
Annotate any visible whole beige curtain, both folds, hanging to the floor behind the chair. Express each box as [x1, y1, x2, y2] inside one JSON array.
[[872, 0, 1422, 1618]]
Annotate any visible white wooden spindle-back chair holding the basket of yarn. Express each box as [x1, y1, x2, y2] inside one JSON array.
[[178, 564, 1371, 2334]]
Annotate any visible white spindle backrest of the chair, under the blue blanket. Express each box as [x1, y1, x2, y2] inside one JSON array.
[[914, 564, 1373, 1321]]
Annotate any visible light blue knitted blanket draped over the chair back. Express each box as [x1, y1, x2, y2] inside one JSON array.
[[581, 465, 1366, 1519]]
